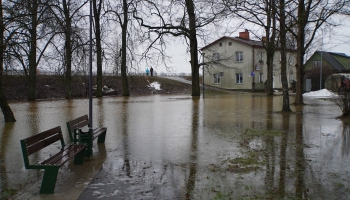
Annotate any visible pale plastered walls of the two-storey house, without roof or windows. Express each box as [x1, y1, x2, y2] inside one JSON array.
[[203, 39, 296, 90]]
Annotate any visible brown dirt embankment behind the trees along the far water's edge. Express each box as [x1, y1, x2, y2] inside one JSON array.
[[3, 75, 192, 101]]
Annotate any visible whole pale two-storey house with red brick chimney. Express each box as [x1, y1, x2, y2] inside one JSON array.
[[200, 30, 296, 91]]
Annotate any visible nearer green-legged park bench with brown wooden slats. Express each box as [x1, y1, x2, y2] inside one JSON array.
[[21, 126, 86, 194]]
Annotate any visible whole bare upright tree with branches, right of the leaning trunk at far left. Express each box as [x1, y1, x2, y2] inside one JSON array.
[[8, 0, 55, 101]]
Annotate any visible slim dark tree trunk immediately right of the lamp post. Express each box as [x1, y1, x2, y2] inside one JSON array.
[[93, 0, 102, 97]]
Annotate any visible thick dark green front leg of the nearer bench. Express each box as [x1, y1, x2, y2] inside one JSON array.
[[40, 167, 59, 194]]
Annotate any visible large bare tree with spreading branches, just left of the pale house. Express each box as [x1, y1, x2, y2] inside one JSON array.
[[134, 0, 224, 96]]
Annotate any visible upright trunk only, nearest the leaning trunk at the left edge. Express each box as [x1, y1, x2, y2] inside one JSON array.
[[28, 0, 38, 101]]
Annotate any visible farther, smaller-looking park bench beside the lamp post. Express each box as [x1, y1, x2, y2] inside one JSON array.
[[67, 115, 107, 157]]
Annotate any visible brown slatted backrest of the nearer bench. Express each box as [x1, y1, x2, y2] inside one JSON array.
[[21, 126, 65, 169]]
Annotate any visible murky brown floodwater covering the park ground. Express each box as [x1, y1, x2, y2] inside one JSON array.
[[0, 93, 350, 199]]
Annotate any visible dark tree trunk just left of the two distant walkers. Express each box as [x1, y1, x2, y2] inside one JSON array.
[[121, 0, 130, 96]]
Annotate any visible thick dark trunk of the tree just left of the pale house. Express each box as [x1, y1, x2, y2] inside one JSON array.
[[186, 0, 200, 96]]
